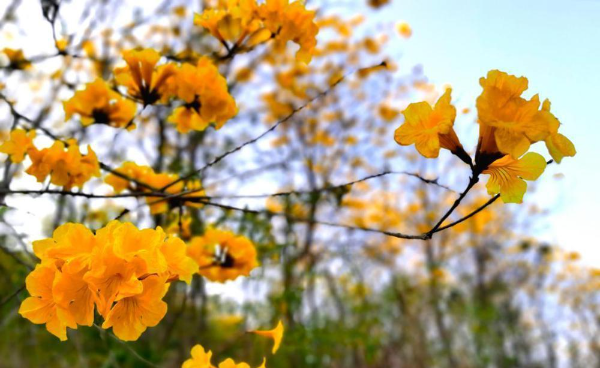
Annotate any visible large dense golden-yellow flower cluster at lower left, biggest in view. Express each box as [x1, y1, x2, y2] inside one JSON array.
[[19, 221, 198, 341]]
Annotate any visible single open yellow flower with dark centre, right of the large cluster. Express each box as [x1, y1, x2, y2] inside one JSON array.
[[188, 228, 258, 282]]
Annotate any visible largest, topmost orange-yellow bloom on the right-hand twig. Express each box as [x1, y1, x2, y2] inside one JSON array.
[[477, 70, 558, 159]]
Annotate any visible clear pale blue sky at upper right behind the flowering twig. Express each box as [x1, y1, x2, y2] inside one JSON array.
[[379, 0, 600, 265]]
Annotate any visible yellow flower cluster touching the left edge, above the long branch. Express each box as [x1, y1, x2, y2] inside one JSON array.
[[0, 129, 100, 190]]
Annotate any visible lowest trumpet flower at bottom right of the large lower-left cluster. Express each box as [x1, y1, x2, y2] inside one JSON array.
[[102, 275, 169, 341]]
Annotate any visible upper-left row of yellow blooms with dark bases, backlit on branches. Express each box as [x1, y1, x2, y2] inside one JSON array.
[[64, 49, 237, 133]]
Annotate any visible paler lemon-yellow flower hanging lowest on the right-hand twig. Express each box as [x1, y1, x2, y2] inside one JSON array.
[[483, 152, 546, 203]]
